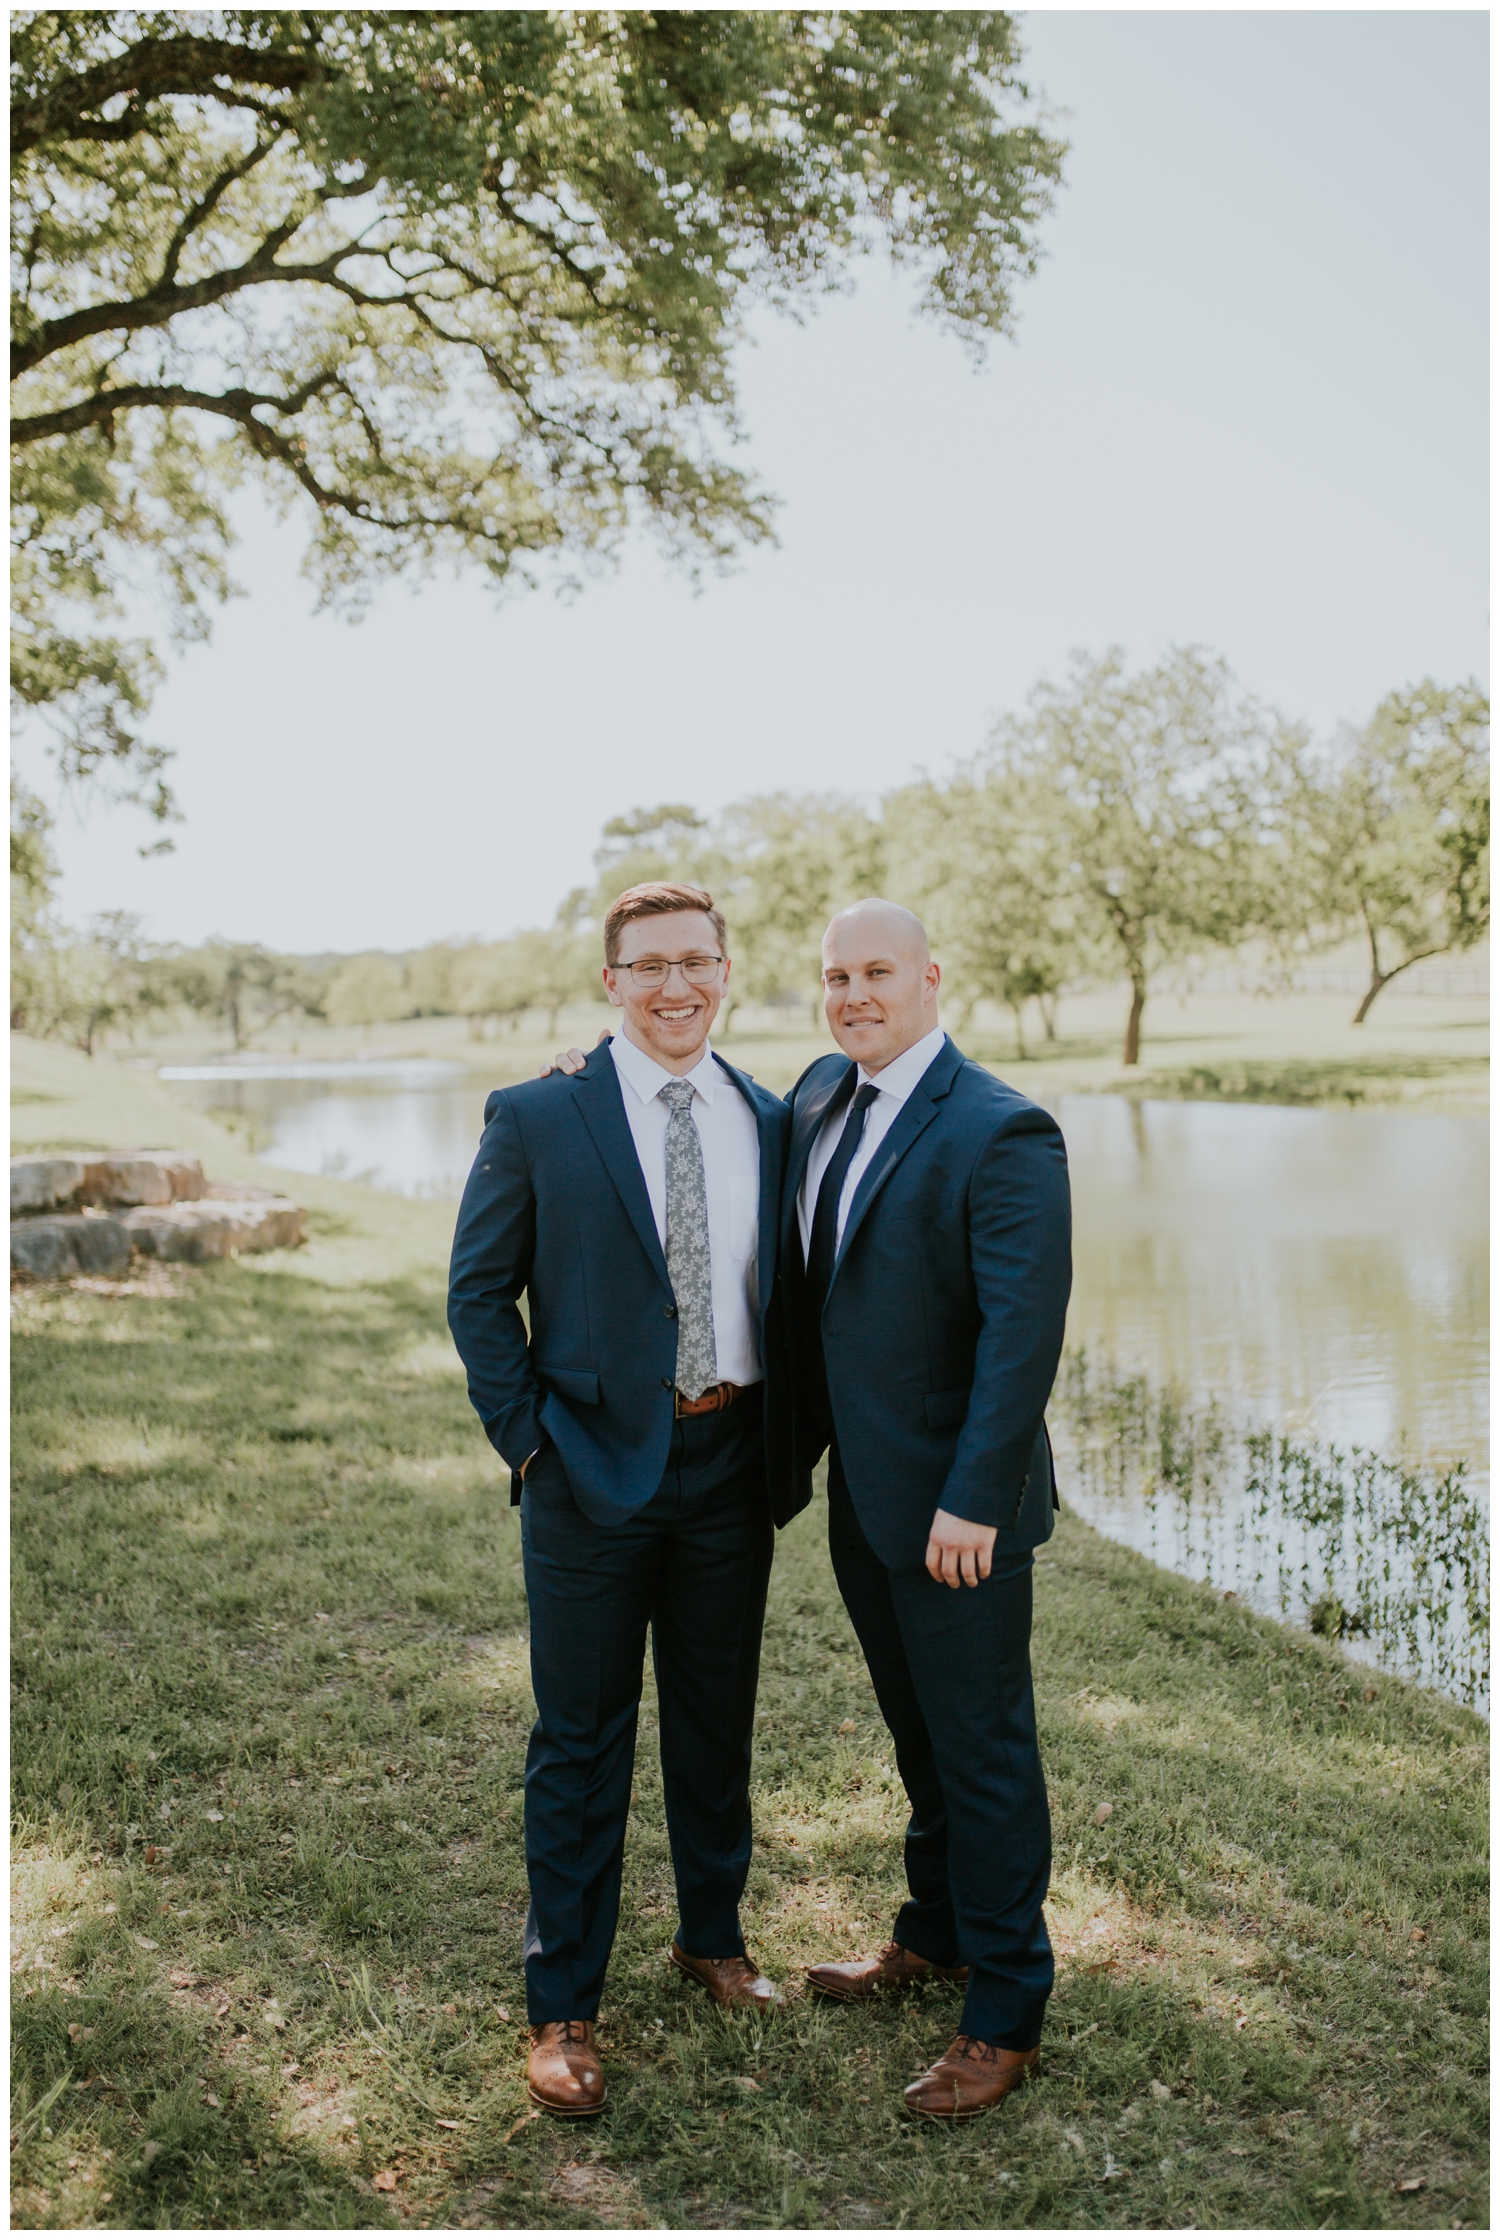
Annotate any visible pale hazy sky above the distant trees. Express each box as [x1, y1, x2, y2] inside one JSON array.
[[18, 11, 1489, 952]]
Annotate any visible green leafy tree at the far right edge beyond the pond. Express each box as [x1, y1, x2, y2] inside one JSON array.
[[1290, 679, 1489, 1026]]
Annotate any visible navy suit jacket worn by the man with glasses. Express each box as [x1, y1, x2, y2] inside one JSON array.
[[448, 1044, 813, 1525]]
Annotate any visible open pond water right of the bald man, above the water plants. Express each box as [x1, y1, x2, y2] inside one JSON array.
[[1059, 1098, 1489, 1463]]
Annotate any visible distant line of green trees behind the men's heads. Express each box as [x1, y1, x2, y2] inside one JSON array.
[[11, 647, 1489, 1066]]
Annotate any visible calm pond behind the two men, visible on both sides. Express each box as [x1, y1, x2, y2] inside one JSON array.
[[163, 1060, 1489, 1684]]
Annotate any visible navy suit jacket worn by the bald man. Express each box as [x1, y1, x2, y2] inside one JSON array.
[[781, 1039, 1072, 1568]]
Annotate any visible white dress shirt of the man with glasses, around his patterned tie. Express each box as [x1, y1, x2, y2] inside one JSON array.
[[609, 1035, 766, 1384]]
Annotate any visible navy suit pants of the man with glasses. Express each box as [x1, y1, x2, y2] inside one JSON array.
[[522, 1391, 775, 2025]]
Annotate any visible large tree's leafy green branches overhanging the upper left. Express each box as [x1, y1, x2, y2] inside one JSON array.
[[11, 9, 1063, 811]]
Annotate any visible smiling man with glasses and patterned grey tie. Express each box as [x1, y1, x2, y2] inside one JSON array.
[[448, 883, 810, 2115]]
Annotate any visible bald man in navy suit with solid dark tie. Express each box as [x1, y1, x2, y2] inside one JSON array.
[[781, 900, 1070, 2121]]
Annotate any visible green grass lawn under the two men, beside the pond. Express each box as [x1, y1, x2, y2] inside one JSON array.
[[11, 1062, 1487, 2229]]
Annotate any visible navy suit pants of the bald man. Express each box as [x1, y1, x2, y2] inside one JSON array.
[[828, 1447, 1052, 2052]]
